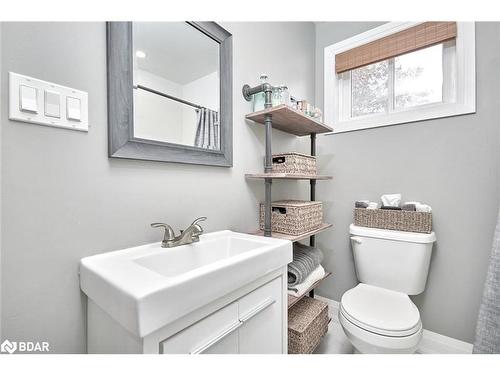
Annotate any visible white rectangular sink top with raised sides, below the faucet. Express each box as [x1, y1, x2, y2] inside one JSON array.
[[80, 230, 292, 337]]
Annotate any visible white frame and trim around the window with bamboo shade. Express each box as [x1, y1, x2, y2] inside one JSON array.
[[324, 22, 476, 133]]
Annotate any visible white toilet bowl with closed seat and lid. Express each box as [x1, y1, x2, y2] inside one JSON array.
[[339, 283, 422, 354]]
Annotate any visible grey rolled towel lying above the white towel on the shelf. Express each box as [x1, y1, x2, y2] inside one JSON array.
[[288, 242, 323, 287]]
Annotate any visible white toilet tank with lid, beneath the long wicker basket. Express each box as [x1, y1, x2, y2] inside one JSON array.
[[349, 224, 436, 295]]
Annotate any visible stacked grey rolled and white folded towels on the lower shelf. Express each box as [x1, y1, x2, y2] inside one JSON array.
[[288, 242, 325, 297]]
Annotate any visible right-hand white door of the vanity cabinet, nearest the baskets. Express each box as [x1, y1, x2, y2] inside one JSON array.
[[238, 277, 284, 354]]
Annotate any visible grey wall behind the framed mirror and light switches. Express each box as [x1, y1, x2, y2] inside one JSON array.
[[1, 23, 314, 353]]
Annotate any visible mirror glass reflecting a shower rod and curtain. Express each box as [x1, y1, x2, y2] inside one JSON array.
[[132, 22, 221, 150]]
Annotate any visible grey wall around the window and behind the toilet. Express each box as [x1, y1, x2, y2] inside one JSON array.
[[316, 23, 500, 342]]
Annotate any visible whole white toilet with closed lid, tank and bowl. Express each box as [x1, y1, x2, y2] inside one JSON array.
[[339, 224, 436, 354]]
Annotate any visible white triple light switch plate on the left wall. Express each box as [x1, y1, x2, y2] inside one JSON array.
[[9, 72, 89, 132]]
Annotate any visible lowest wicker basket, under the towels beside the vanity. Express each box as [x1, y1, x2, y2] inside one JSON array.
[[288, 296, 329, 354]]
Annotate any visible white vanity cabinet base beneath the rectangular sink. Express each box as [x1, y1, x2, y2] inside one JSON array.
[[88, 267, 287, 354]]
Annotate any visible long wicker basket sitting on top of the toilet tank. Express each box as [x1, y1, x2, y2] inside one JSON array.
[[354, 208, 432, 233]]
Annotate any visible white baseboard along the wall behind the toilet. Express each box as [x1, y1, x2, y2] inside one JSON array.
[[315, 295, 472, 354]]
